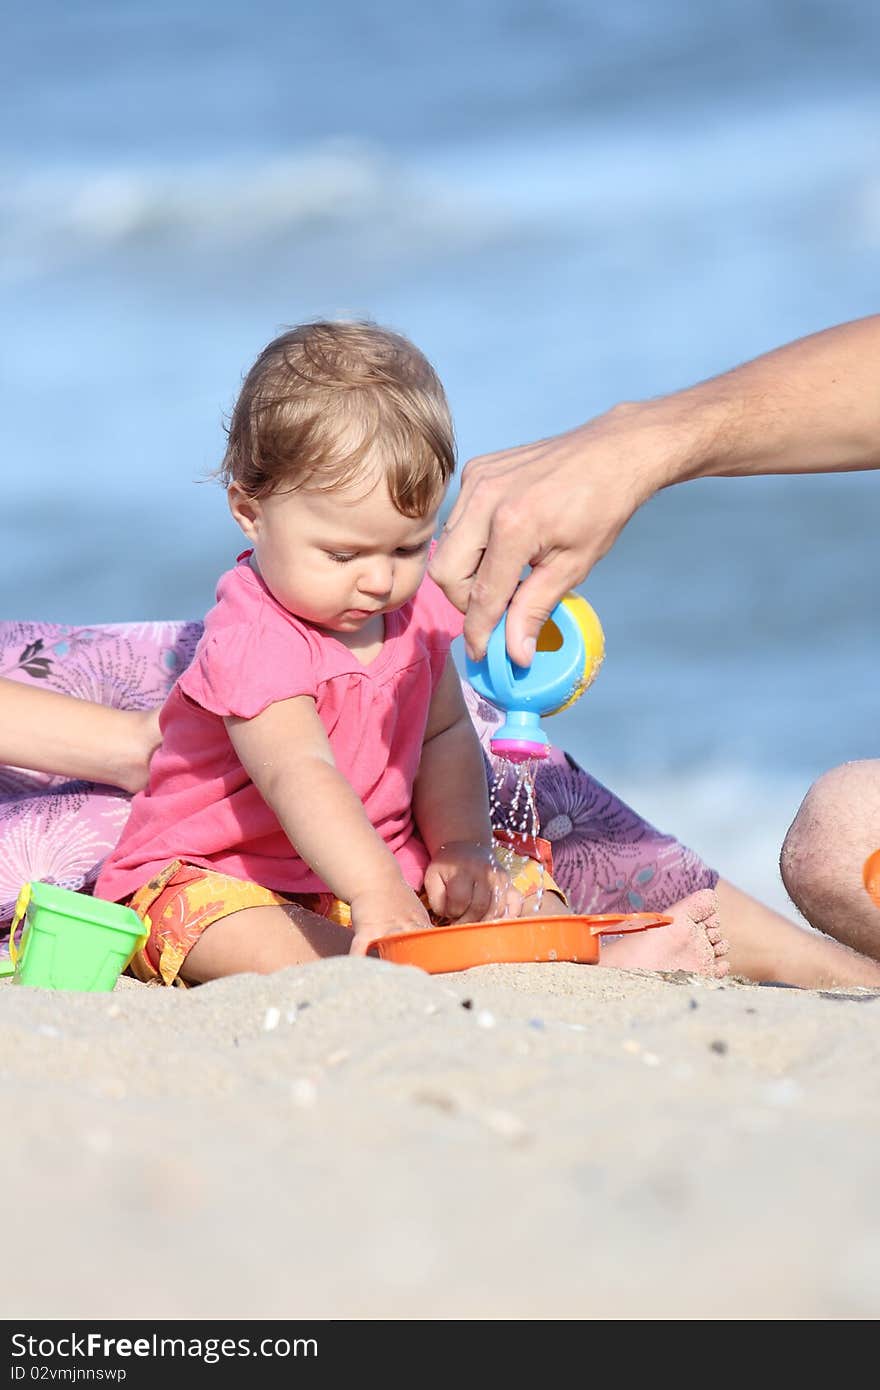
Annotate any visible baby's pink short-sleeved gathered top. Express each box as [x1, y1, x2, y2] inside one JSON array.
[[95, 552, 462, 901]]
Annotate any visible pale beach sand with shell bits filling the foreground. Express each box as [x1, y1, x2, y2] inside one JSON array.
[[0, 958, 880, 1321]]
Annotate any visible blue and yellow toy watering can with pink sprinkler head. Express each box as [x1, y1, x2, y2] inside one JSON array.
[[466, 594, 605, 763]]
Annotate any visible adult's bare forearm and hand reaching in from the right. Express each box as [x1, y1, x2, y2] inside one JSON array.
[[430, 314, 880, 666]]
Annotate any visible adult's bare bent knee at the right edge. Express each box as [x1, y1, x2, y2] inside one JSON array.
[[780, 759, 880, 956]]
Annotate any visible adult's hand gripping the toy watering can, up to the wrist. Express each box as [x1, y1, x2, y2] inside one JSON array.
[[430, 402, 670, 666]]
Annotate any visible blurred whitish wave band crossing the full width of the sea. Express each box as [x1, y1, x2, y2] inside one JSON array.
[[6, 86, 880, 277]]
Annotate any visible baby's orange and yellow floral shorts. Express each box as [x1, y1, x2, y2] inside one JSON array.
[[127, 831, 566, 988]]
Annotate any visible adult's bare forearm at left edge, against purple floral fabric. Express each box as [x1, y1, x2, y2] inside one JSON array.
[[0, 677, 160, 792]]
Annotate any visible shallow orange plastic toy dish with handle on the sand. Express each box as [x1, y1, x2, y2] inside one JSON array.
[[371, 912, 673, 974]]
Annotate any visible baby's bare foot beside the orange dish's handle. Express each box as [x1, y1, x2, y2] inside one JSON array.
[[599, 888, 730, 980]]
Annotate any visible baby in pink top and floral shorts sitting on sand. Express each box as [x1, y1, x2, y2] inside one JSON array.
[[95, 322, 727, 986]]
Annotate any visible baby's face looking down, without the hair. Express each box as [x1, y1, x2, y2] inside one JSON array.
[[229, 477, 442, 634]]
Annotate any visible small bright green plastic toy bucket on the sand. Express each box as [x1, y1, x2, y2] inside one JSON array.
[[10, 883, 149, 992]]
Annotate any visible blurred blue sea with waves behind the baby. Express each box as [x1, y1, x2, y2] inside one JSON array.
[[0, 0, 880, 910]]
